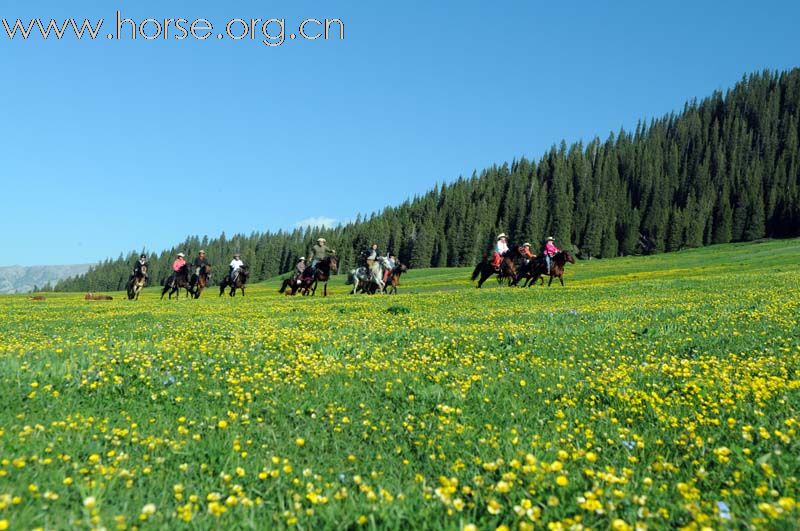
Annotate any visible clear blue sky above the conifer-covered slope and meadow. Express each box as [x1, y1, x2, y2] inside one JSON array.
[[0, 0, 800, 265]]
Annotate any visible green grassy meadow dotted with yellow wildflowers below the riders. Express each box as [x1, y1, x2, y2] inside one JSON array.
[[0, 240, 800, 530]]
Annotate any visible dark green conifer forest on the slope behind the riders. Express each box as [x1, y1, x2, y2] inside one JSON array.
[[56, 69, 800, 291]]
